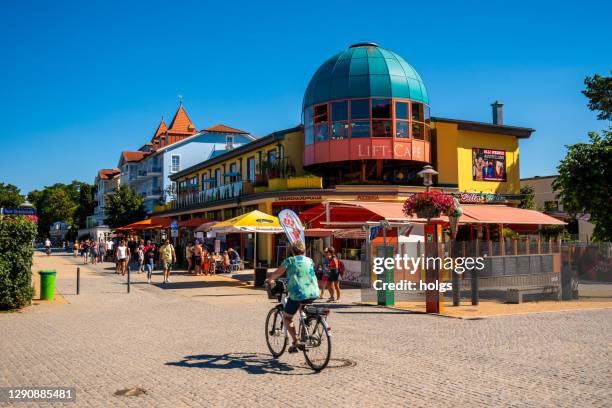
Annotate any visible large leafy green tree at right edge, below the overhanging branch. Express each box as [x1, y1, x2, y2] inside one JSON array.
[[553, 130, 612, 241]]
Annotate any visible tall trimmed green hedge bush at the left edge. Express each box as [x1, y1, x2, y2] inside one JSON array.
[[0, 217, 36, 309]]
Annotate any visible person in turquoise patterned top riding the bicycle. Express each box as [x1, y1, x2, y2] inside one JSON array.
[[267, 241, 319, 353]]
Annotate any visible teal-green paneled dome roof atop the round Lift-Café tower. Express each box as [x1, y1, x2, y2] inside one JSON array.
[[304, 43, 429, 107]]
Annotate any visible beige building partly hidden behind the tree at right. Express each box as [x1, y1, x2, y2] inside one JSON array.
[[521, 175, 594, 242]]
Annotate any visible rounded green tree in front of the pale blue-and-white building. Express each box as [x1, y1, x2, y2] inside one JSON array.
[[104, 186, 146, 228]]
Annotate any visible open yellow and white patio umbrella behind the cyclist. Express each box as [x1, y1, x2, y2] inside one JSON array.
[[210, 210, 283, 267]]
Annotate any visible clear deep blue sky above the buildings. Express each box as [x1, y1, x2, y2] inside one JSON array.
[[0, 0, 612, 192]]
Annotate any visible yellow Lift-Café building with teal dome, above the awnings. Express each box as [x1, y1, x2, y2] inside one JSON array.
[[156, 43, 533, 261]]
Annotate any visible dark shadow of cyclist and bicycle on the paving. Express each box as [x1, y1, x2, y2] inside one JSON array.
[[165, 353, 315, 375]]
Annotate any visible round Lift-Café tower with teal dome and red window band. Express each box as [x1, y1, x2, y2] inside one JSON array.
[[302, 43, 430, 167]]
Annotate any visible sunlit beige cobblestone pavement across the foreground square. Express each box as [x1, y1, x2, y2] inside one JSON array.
[[0, 256, 612, 408]]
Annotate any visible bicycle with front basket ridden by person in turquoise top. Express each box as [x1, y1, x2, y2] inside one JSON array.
[[266, 278, 332, 371]]
